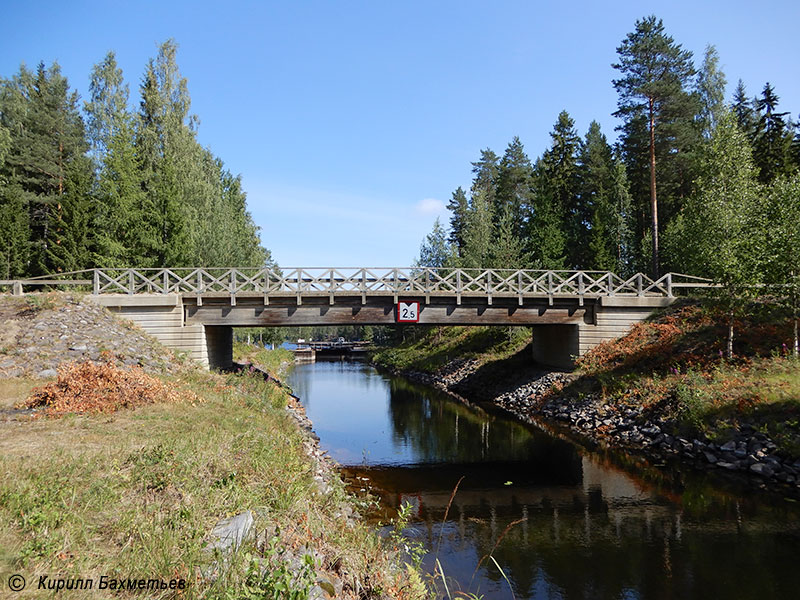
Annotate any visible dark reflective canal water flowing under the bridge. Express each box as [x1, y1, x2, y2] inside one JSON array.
[[291, 361, 800, 600]]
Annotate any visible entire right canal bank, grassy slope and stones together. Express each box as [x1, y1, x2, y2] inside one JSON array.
[[375, 302, 800, 498]]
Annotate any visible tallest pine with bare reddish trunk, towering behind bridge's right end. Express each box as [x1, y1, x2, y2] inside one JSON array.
[[612, 16, 695, 276]]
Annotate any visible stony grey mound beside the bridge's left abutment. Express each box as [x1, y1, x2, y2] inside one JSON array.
[[0, 294, 181, 378]]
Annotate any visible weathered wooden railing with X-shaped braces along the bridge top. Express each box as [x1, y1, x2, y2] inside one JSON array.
[[0, 267, 713, 303]]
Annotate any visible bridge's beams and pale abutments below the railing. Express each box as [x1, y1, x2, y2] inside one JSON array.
[[93, 294, 674, 369]]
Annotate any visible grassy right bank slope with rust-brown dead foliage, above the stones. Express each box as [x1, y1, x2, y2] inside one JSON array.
[[374, 301, 800, 457]]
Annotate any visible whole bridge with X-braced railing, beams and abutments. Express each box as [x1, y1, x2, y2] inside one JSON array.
[[0, 267, 711, 368]]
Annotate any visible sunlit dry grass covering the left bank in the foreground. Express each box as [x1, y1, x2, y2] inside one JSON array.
[[0, 344, 424, 599]]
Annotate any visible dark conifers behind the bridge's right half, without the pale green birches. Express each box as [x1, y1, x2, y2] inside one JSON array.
[[417, 16, 800, 276]]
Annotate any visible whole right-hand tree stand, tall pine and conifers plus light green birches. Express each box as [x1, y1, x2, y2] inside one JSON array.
[[416, 16, 800, 356]]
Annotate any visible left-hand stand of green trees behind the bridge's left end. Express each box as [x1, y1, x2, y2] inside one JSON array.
[[0, 40, 271, 279]]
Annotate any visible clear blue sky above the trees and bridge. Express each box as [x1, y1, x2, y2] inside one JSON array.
[[0, 0, 800, 266]]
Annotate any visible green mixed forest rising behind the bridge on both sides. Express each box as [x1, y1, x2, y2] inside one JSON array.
[[0, 16, 800, 300]]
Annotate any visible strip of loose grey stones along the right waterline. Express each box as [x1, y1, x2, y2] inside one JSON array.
[[390, 360, 800, 497]]
